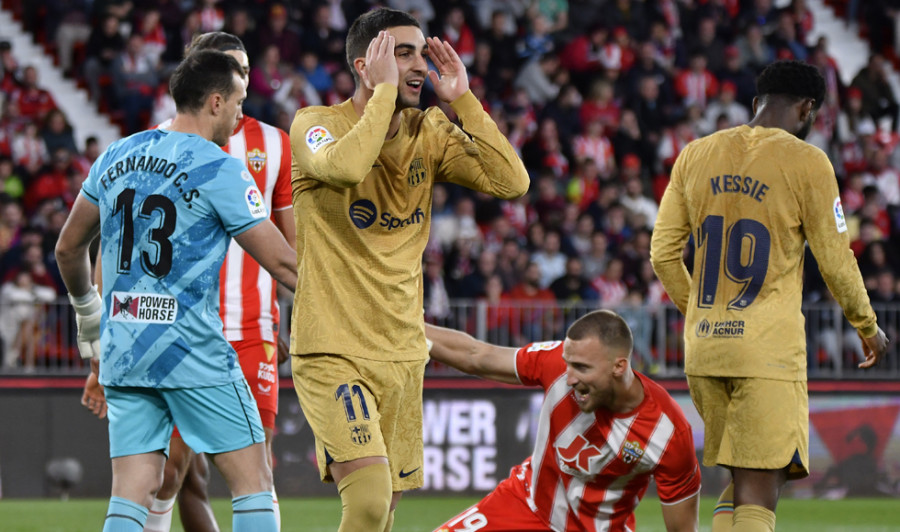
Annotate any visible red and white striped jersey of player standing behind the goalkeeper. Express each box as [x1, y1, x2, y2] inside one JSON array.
[[219, 115, 291, 342]]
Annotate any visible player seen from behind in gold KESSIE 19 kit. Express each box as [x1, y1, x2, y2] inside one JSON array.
[[650, 61, 887, 532]]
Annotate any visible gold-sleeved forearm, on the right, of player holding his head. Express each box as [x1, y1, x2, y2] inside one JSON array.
[[446, 92, 530, 199]]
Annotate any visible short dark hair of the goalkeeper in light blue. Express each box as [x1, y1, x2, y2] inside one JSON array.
[[169, 50, 244, 113]]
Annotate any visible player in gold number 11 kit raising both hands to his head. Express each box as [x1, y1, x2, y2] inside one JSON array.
[[291, 9, 528, 532]]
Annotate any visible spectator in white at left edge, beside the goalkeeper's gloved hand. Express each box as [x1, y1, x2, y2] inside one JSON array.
[[0, 270, 56, 371]]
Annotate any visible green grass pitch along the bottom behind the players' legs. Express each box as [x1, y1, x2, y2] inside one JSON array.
[[0, 496, 900, 532]]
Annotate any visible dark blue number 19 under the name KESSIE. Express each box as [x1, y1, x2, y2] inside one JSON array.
[[695, 215, 772, 310]]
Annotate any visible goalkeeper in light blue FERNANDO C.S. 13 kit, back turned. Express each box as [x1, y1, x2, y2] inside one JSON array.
[[56, 51, 297, 532]]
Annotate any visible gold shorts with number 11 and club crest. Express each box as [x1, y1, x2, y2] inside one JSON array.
[[291, 355, 426, 491]]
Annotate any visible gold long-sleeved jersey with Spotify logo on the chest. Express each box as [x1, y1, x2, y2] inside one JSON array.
[[291, 84, 528, 360]]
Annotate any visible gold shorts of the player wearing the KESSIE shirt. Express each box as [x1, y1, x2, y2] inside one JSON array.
[[687, 375, 809, 480]]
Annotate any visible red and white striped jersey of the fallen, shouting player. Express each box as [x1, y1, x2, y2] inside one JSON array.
[[513, 342, 700, 532]]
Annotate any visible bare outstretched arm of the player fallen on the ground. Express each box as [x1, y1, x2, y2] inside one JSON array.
[[425, 323, 520, 384]]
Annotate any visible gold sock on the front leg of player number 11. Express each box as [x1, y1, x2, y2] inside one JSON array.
[[338, 464, 392, 532]]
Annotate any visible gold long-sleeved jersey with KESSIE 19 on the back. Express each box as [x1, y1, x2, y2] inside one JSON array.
[[650, 125, 877, 380]]
